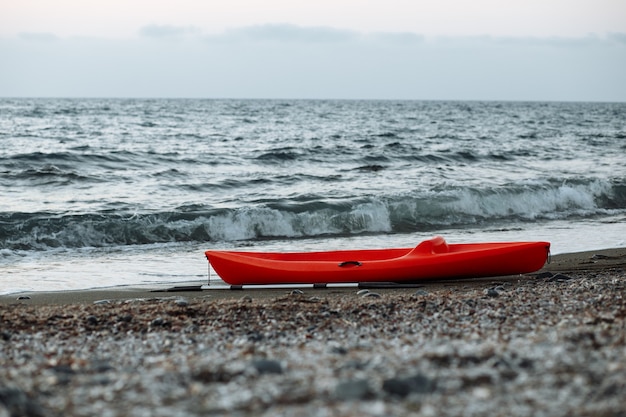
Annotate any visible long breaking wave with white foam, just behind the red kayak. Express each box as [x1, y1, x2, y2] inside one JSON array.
[[0, 181, 626, 251]]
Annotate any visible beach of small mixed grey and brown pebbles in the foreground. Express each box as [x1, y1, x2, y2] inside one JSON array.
[[0, 248, 626, 417]]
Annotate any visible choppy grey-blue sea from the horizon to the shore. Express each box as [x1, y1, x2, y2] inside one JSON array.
[[0, 98, 626, 294]]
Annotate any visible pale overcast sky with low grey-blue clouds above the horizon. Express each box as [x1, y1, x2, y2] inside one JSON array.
[[0, 0, 626, 101]]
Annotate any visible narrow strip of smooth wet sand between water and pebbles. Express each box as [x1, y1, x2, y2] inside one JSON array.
[[0, 248, 626, 305]]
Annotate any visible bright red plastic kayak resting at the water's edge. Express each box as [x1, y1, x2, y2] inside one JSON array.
[[205, 236, 550, 285]]
